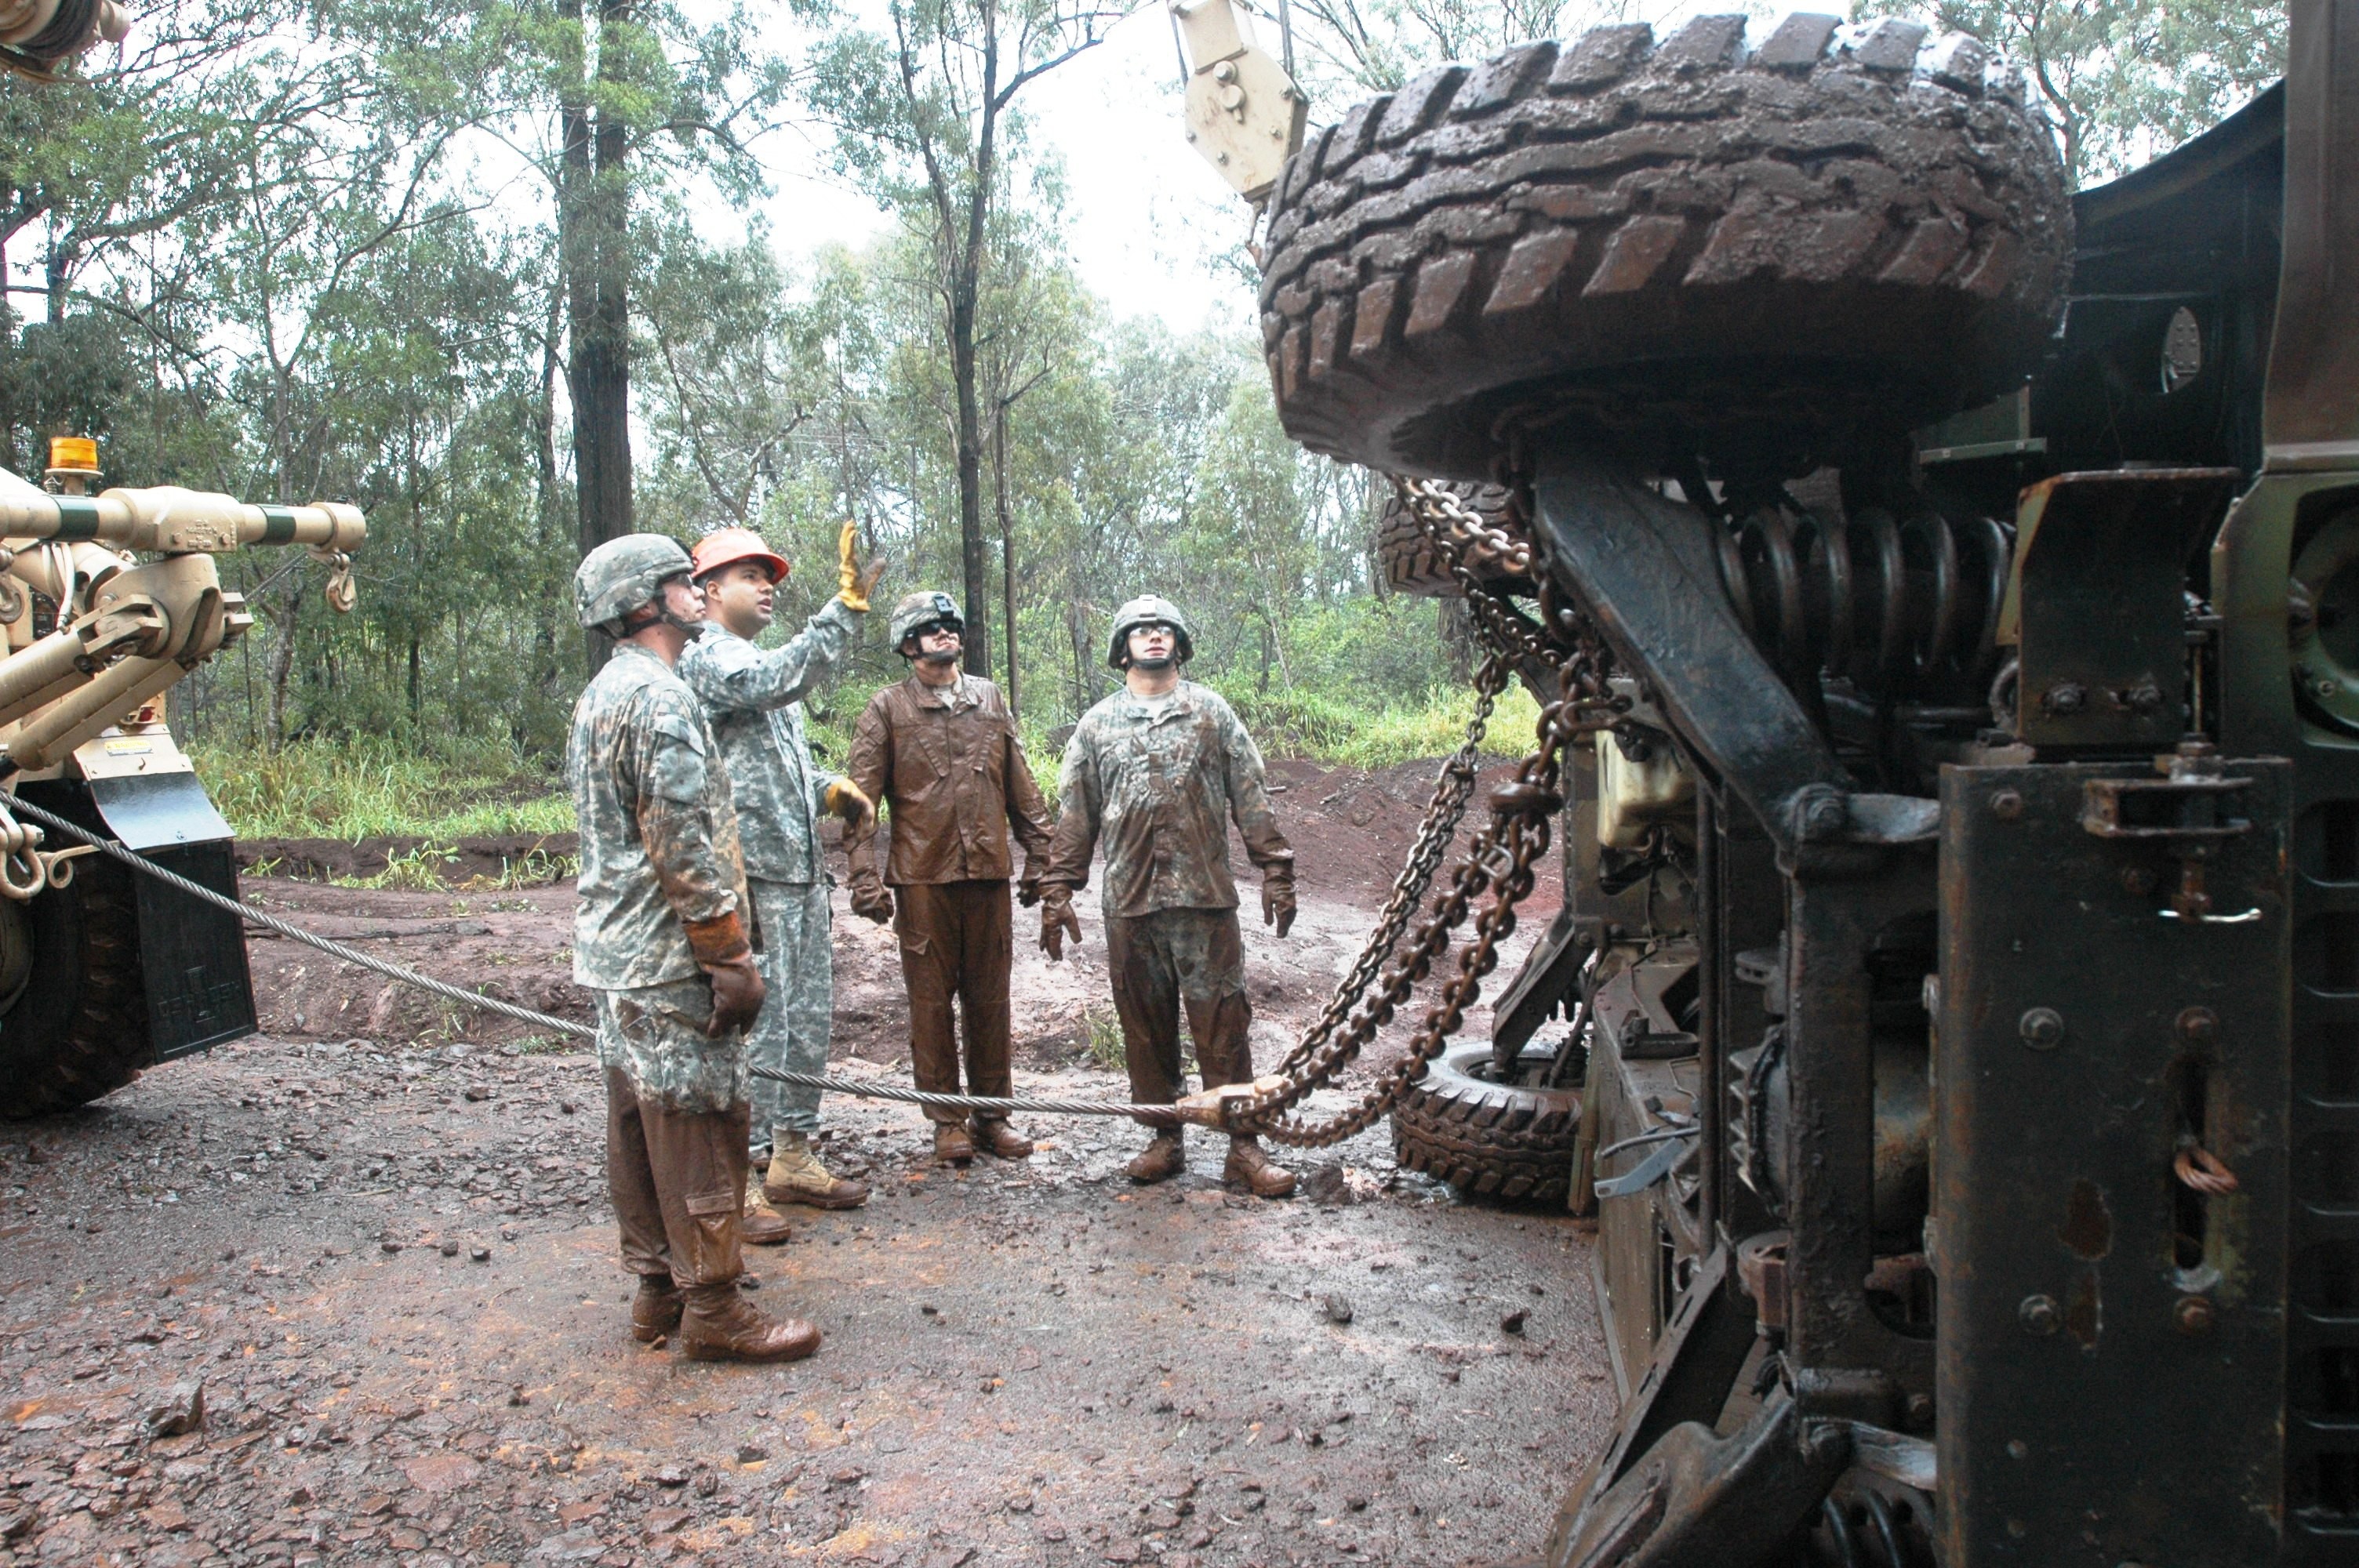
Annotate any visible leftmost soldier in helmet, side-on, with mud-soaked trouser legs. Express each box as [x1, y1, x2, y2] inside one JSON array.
[[566, 533, 819, 1360]]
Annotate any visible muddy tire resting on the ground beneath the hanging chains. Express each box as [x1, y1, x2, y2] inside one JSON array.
[[1392, 1044, 1580, 1203]]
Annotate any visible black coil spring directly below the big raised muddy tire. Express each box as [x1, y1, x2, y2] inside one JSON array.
[[1717, 503, 2015, 700]]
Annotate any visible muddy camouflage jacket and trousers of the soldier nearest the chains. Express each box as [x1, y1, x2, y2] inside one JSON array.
[[1041, 681, 1295, 1106]]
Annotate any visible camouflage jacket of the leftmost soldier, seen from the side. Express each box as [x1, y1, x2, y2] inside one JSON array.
[[566, 644, 746, 990]]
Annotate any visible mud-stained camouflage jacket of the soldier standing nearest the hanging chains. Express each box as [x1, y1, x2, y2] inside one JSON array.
[[1043, 681, 1295, 915]]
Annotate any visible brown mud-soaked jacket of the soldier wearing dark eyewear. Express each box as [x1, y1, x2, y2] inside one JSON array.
[[845, 674, 1048, 887]]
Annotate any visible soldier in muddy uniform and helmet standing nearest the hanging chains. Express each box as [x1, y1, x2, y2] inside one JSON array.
[[1041, 594, 1295, 1198]]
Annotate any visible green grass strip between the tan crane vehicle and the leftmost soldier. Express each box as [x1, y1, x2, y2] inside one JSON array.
[[191, 738, 573, 844]]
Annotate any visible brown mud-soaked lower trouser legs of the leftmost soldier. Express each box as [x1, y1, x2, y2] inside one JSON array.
[[606, 1068, 746, 1287]]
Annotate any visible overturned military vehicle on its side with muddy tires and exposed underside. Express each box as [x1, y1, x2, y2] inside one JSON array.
[[1262, 0, 2359, 1568]]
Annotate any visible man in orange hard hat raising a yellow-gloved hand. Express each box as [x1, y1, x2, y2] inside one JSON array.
[[679, 524, 885, 1210]]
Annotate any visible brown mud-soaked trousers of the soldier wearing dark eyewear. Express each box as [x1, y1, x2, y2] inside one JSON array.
[[892, 880, 1014, 1123]]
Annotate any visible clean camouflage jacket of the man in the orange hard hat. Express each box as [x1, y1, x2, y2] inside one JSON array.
[[679, 599, 859, 882]]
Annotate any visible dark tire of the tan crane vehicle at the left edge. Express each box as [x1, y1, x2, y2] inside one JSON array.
[[0, 856, 154, 1118]]
